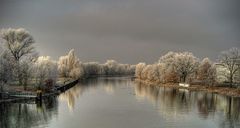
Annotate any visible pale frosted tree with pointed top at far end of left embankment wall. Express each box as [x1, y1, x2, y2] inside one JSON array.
[[58, 49, 84, 79]]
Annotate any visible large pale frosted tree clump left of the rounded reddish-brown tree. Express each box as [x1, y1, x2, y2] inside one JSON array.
[[135, 52, 199, 83]]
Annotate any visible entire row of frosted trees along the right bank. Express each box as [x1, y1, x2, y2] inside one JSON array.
[[135, 48, 240, 87]]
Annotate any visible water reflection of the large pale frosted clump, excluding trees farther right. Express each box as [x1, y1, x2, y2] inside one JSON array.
[[135, 83, 191, 119]]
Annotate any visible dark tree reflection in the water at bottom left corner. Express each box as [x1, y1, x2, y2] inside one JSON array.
[[0, 98, 57, 128]]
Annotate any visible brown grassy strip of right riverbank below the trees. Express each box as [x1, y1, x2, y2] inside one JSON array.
[[135, 79, 240, 97]]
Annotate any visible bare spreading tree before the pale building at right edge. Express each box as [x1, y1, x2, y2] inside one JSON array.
[[219, 48, 240, 86]]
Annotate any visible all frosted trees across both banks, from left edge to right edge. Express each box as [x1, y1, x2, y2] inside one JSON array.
[[0, 28, 240, 91]]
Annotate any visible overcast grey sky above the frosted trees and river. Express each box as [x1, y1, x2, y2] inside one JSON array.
[[0, 0, 240, 63]]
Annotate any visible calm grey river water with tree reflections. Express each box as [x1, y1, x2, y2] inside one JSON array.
[[0, 77, 240, 128]]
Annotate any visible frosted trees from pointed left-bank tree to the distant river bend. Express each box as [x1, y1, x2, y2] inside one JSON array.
[[58, 49, 135, 79]]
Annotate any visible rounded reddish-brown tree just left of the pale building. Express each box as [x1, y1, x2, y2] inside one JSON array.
[[197, 58, 216, 85]]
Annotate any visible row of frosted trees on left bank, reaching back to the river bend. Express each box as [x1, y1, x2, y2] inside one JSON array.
[[0, 28, 135, 91]]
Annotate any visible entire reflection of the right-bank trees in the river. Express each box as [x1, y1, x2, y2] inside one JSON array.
[[135, 83, 240, 126]]
